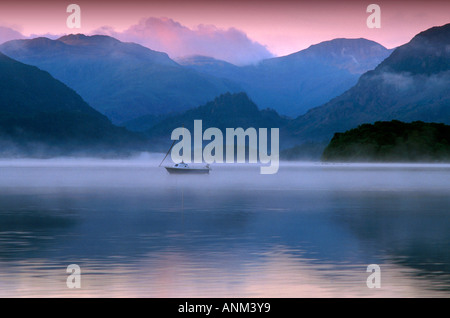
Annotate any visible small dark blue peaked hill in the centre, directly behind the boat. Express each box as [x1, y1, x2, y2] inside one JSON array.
[[146, 93, 290, 149]]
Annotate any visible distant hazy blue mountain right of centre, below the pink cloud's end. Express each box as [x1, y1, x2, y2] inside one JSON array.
[[178, 39, 391, 117]]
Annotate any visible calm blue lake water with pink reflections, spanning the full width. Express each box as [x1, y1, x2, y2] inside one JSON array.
[[0, 158, 450, 297]]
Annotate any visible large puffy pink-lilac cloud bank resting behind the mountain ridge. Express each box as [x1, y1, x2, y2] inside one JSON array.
[[93, 17, 273, 65]]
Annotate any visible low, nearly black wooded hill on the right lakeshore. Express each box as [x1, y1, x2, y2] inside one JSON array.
[[322, 120, 450, 162]]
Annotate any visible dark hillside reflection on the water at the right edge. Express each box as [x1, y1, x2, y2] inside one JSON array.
[[333, 192, 450, 290]]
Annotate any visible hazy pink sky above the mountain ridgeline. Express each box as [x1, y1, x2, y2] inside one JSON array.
[[0, 0, 450, 58]]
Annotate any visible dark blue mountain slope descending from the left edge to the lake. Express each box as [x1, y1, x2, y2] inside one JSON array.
[[0, 53, 145, 156]]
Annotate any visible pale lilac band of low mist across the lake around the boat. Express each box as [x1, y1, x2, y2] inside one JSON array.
[[0, 153, 450, 194]]
